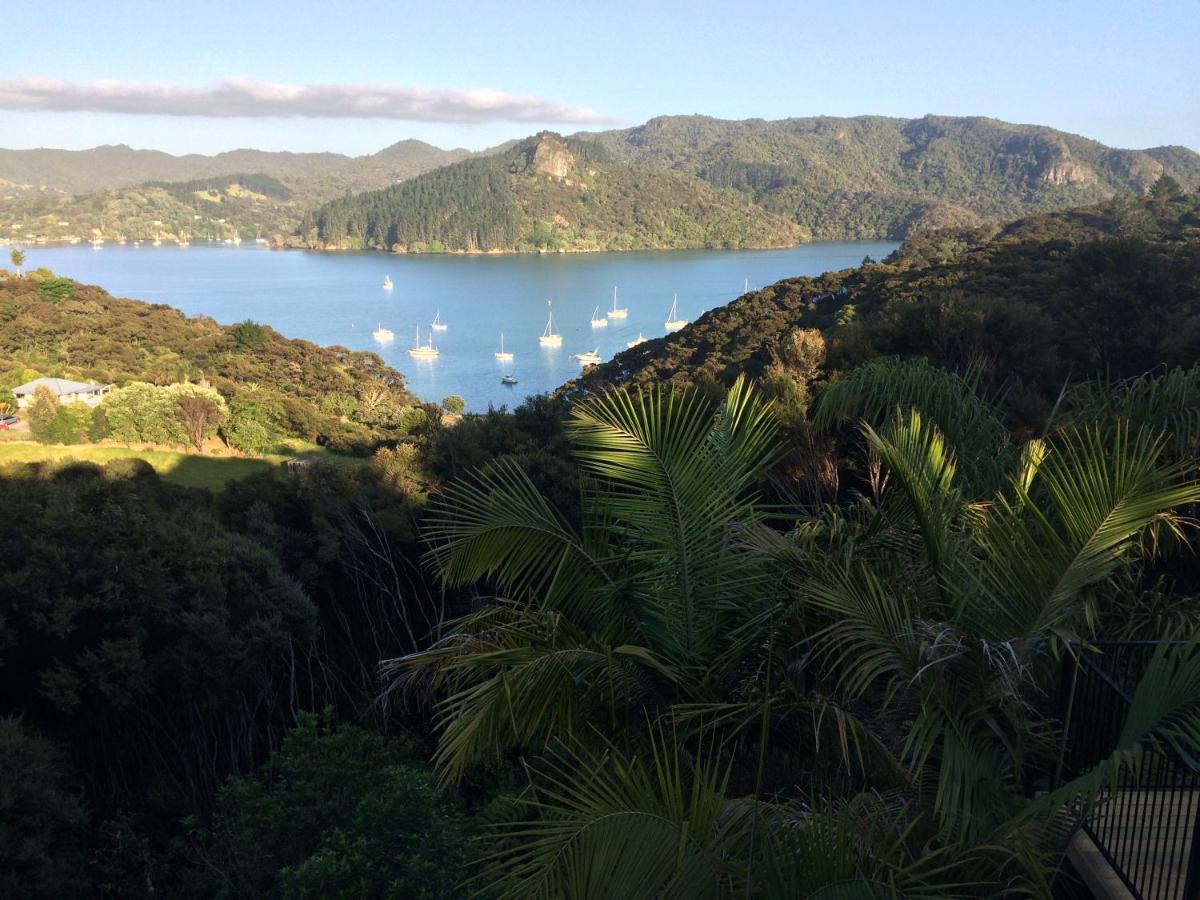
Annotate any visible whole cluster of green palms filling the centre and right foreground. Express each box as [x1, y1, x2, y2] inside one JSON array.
[[389, 364, 1200, 898]]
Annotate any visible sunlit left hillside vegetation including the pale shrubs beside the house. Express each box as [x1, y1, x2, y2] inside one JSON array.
[[0, 270, 438, 455]]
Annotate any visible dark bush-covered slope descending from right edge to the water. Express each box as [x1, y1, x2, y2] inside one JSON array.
[[562, 187, 1200, 426]]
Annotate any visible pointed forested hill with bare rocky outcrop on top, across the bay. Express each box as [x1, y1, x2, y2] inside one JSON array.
[[301, 133, 809, 252]]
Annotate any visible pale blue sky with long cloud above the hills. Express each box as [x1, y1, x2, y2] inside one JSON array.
[[0, 0, 1200, 155]]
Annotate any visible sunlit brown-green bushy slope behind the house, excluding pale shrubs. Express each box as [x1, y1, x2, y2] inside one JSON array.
[[0, 269, 420, 450]]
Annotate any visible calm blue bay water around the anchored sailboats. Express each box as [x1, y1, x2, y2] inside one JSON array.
[[29, 241, 896, 410]]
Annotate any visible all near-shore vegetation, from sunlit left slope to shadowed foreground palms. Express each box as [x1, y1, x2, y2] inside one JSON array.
[[0, 187, 1200, 900]]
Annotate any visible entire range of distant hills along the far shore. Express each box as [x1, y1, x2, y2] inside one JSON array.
[[9, 115, 1200, 252]]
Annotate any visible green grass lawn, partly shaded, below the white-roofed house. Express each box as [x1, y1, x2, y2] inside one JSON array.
[[0, 443, 288, 491]]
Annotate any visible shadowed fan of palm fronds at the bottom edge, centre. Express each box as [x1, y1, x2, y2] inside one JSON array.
[[479, 730, 750, 900]]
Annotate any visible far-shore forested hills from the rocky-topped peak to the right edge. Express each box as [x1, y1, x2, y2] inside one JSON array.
[[301, 116, 1200, 251]]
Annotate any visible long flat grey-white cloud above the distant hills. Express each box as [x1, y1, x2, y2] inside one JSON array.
[[0, 78, 613, 125]]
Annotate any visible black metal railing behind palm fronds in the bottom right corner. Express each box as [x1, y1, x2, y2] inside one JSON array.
[[1063, 641, 1200, 900]]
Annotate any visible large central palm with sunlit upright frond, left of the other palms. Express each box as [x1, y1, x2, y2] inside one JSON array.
[[384, 380, 779, 780]]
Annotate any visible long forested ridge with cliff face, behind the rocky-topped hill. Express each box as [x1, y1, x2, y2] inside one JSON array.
[[580, 115, 1200, 239]]
